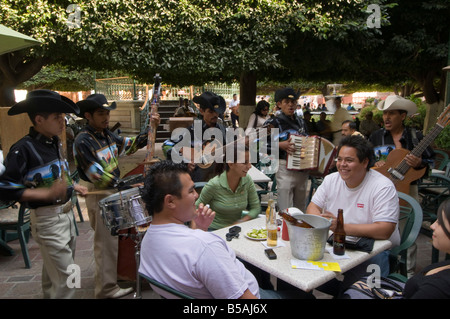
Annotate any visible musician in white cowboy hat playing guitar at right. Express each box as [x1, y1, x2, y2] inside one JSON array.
[[369, 95, 435, 275]]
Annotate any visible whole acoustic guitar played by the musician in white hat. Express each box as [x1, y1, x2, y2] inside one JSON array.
[[372, 104, 450, 194]]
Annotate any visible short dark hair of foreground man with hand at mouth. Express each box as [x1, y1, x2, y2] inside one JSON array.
[[141, 160, 189, 215]]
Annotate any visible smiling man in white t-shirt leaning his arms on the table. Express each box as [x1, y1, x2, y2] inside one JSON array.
[[306, 135, 400, 296]]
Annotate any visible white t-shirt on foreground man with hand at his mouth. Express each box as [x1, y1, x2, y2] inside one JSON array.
[[139, 218, 259, 299]]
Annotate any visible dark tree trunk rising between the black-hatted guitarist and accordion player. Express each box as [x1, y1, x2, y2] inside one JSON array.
[[239, 71, 256, 130]]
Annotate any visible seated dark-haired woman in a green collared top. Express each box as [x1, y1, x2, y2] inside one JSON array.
[[196, 143, 261, 230]]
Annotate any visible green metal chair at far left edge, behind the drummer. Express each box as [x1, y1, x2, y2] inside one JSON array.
[[0, 205, 31, 268]]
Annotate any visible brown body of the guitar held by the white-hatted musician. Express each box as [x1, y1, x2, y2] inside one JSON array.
[[372, 148, 426, 194]]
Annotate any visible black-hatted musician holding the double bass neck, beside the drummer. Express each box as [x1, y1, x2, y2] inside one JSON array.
[[73, 94, 159, 298]]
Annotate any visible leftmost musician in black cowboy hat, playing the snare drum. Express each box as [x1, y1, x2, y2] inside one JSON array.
[[0, 90, 87, 299]]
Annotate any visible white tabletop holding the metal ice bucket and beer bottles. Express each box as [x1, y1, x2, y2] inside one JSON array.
[[214, 218, 391, 291]]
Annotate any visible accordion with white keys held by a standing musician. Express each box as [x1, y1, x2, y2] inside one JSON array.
[[286, 134, 336, 177]]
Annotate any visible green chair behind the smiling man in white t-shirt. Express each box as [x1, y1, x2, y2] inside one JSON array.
[[389, 192, 423, 277]]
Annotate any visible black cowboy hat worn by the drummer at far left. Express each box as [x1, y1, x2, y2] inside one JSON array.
[[8, 90, 79, 115]]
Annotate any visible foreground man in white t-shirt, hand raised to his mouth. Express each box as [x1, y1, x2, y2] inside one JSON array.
[[139, 161, 310, 299]]
